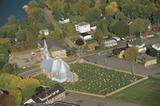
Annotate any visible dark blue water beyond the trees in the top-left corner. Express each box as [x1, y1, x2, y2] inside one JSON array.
[[0, 0, 29, 26]]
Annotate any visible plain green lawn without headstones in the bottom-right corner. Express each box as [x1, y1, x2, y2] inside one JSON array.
[[112, 78, 160, 106]]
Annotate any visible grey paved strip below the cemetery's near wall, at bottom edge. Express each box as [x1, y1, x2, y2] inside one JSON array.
[[64, 93, 140, 106]]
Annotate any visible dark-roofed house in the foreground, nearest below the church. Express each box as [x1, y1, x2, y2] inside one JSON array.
[[24, 84, 66, 105]]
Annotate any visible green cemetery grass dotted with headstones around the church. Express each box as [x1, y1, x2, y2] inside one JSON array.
[[36, 63, 141, 95]]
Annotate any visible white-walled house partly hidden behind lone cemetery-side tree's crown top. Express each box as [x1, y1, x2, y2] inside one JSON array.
[[128, 40, 147, 53]]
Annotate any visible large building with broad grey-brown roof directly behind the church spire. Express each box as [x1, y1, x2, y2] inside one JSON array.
[[38, 38, 67, 58]]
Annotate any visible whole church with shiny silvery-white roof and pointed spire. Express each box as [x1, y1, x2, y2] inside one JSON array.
[[41, 40, 78, 83]]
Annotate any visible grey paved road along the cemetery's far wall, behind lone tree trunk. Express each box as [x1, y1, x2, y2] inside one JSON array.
[[84, 53, 160, 75]]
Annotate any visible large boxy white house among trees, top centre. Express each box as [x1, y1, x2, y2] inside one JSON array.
[[75, 22, 91, 33]]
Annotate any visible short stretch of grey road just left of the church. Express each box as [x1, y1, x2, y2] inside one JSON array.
[[18, 67, 42, 78]]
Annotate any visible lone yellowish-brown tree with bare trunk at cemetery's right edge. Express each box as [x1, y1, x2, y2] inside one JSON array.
[[124, 46, 138, 74]]
